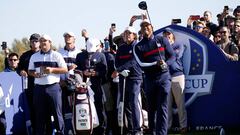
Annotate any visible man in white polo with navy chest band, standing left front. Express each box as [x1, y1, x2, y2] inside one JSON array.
[[28, 35, 67, 135]]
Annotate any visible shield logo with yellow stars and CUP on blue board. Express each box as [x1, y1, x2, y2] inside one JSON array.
[[179, 31, 214, 106]]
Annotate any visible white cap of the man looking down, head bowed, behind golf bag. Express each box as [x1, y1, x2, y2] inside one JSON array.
[[86, 38, 101, 52]]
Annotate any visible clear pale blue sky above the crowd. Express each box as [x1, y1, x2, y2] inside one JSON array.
[[0, 0, 240, 48]]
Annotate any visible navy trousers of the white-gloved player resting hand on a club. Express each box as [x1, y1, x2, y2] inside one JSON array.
[[119, 78, 142, 134]]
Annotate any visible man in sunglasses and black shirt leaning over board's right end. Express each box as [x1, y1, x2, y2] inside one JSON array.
[[219, 27, 239, 61]]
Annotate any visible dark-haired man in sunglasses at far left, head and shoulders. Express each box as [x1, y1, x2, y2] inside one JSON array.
[[4, 53, 19, 72]]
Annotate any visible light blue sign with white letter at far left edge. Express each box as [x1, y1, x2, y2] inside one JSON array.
[[0, 72, 27, 135]]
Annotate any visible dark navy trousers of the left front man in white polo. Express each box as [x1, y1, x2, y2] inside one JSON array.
[[33, 83, 64, 135]]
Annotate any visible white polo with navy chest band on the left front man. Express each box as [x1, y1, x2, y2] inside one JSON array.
[[28, 50, 67, 85]]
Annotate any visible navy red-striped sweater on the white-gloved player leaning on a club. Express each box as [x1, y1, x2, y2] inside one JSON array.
[[115, 41, 142, 79]]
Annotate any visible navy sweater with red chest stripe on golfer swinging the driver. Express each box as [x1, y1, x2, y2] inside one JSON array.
[[134, 36, 176, 76]]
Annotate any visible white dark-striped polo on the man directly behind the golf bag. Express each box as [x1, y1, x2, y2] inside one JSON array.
[[59, 48, 81, 80]]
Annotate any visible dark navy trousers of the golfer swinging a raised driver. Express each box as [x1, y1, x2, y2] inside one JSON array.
[[144, 73, 171, 135]]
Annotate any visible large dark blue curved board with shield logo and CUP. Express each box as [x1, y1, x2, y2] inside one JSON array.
[[155, 25, 240, 130]]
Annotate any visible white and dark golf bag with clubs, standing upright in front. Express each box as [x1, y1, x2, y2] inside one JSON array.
[[67, 70, 99, 135]]
